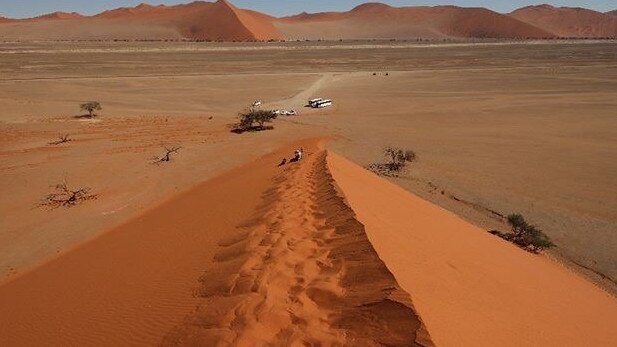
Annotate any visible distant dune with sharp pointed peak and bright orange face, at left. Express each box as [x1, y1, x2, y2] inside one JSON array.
[[0, 0, 281, 41]]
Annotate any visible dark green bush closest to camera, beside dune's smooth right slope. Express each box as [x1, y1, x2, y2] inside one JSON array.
[[490, 213, 555, 253]]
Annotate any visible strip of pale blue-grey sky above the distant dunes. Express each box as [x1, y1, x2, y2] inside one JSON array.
[[0, 0, 617, 18]]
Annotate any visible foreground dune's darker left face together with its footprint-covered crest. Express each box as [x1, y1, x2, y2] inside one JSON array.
[[0, 141, 432, 346]]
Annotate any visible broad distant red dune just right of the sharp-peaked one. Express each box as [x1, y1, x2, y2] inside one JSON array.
[[275, 3, 554, 39]]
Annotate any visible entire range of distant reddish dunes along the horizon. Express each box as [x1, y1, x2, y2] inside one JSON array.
[[0, 0, 617, 41]]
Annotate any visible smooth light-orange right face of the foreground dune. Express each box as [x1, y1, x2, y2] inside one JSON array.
[[328, 153, 617, 346]]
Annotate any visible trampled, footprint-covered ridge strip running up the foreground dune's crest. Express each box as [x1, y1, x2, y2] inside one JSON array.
[[163, 150, 432, 346]]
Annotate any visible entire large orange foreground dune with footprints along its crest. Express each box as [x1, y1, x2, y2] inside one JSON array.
[[0, 140, 617, 346]]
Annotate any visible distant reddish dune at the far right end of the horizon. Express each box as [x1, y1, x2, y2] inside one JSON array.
[[510, 5, 617, 37]]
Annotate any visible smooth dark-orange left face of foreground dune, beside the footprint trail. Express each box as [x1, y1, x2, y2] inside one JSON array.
[[0, 141, 296, 346]]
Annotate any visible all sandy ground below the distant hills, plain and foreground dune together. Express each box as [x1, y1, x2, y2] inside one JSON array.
[[0, 40, 617, 346]]
